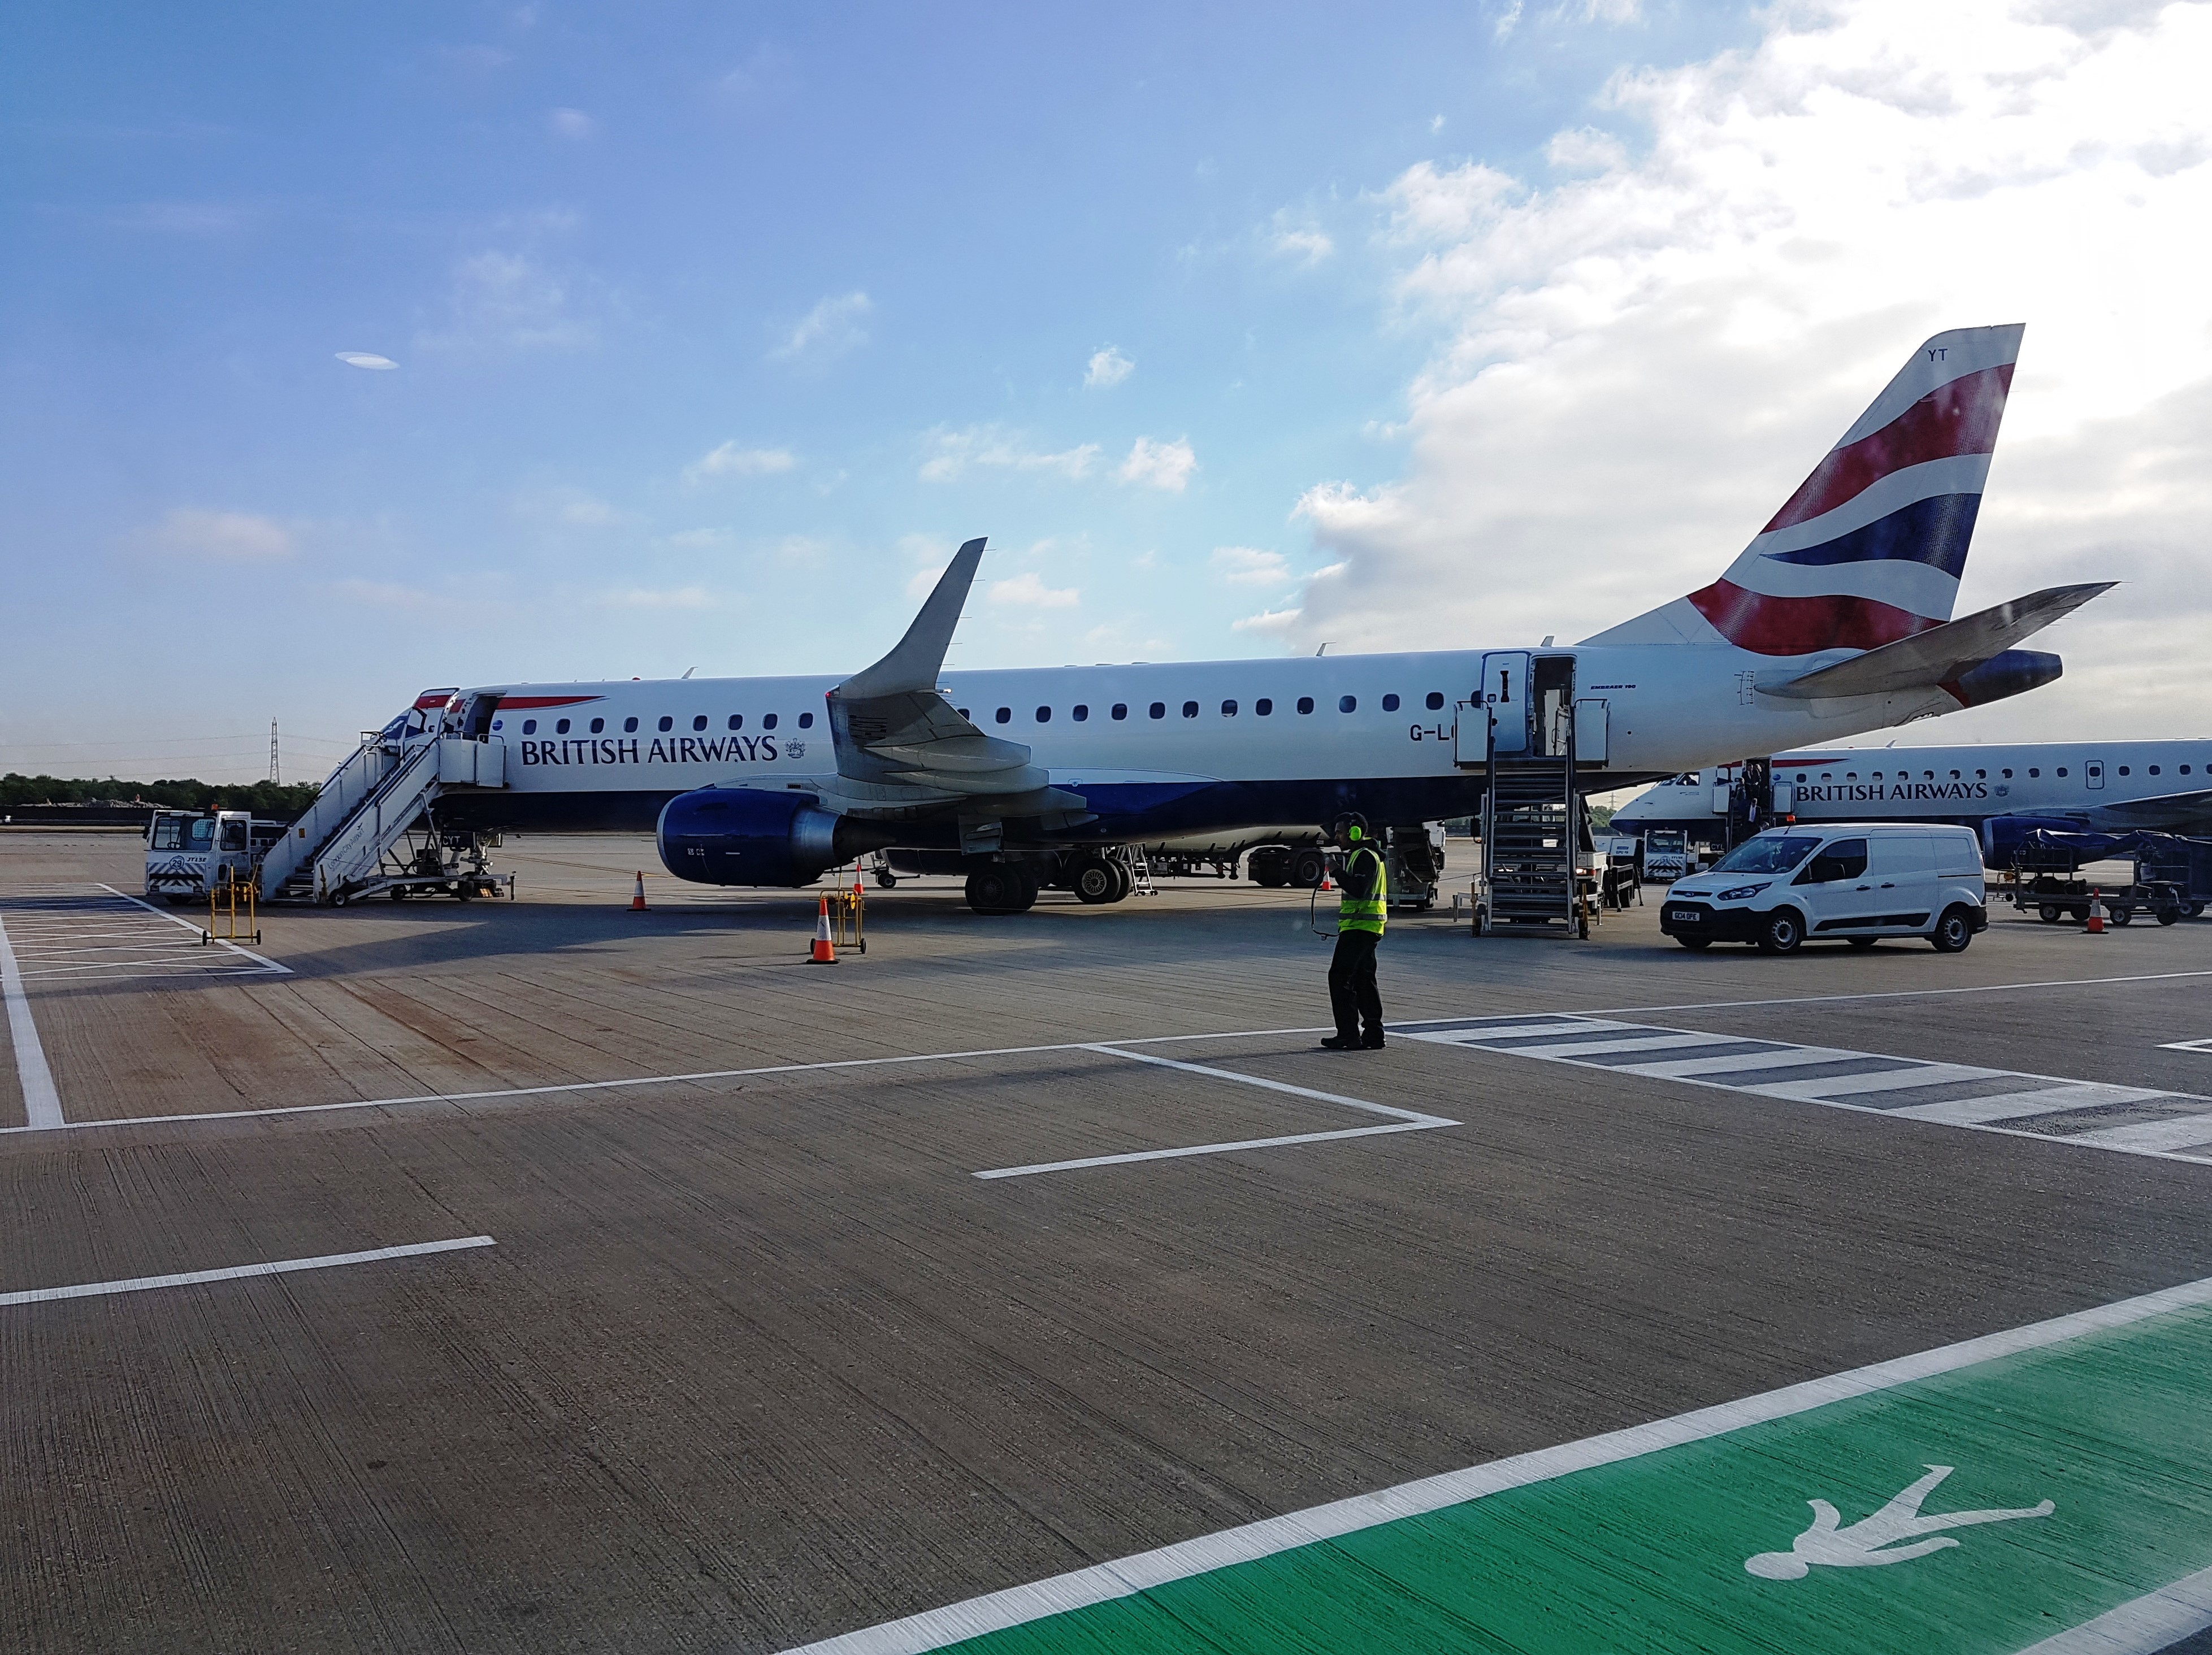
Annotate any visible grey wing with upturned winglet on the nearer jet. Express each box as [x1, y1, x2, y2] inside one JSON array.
[[830, 540, 1082, 810]]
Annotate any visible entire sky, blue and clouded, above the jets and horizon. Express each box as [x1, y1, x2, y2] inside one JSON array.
[[0, 0, 2212, 776]]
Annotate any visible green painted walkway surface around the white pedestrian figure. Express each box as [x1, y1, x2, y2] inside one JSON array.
[[809, 1308, 2212, 1655]]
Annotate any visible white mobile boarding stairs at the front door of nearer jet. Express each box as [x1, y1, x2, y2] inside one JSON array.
[[259, 703, 513, 905]]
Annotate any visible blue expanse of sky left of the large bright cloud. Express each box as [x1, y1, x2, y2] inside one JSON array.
[[0, 5, 1745, 775]]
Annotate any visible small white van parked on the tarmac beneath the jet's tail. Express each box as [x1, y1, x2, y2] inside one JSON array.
[[1659, 823, 1989, 954]]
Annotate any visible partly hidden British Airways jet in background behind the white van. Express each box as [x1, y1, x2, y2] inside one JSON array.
[[1612, 741, 2212, 867]]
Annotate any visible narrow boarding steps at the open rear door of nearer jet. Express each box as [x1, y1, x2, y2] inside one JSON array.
[[1460, 650, 1606, 936]]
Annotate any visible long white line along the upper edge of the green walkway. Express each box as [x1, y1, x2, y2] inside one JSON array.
[[785, 1279, 2212, 1655]]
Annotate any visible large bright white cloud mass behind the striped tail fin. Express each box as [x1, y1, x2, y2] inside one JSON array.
[[1294, 0, 2212, 730]]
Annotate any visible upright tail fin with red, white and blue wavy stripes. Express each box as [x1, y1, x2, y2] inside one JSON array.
[[1586, 323, 2024, 657]]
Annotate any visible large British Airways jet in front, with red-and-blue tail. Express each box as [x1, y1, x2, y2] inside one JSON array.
[[418, 325, 2110, 911]]
